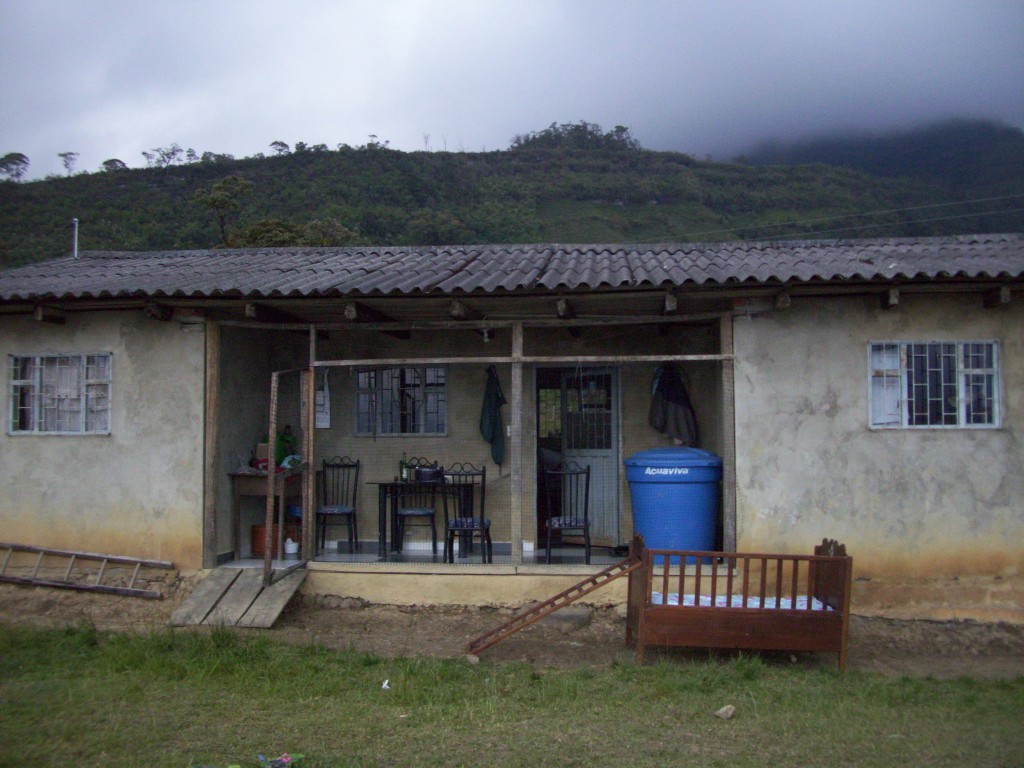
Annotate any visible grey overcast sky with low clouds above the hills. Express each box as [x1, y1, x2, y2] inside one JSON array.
[[0, 0, 1024, 178]]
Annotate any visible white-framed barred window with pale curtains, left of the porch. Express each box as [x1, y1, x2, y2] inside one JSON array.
[[7, 353, 113, 434]]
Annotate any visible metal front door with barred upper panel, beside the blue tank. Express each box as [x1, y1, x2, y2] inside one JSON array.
[[537, 367, 618, 547]]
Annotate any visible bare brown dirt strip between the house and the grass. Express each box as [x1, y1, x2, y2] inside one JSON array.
[[0, 584, 1024, 679]]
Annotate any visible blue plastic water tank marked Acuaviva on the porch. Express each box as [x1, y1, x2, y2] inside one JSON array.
[[625, 447, 722, 565]]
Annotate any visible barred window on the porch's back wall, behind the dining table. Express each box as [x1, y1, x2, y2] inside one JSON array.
[[355, 366, 447, 435]]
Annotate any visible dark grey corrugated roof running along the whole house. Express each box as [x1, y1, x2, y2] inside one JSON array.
[[0, 233, 1024, 303]]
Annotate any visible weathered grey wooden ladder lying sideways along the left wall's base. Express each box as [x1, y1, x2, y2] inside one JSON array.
[[0, 542, 174, 600]]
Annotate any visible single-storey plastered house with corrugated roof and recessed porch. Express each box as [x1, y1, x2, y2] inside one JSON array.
[[0, 234, 1024, 622]]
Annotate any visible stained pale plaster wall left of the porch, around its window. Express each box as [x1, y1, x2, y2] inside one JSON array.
[[0, 311, 204, 568]]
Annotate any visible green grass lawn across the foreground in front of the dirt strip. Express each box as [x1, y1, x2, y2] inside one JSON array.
[[0, 627, 1024, 768]]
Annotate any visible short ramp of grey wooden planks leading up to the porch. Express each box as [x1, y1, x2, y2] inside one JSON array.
[[170, 565, 306, 628]]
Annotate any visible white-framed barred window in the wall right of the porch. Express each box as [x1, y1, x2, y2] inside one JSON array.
[[868, 341, 999, 428]]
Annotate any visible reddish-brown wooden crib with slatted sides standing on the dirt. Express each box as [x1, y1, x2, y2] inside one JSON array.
[[626, 536, 853, 670]]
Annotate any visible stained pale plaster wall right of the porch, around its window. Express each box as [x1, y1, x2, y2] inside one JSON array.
[[734, 294, 1024, 579]]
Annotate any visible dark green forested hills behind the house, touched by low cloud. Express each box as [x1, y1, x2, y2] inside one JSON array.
[[0, 118, 1024, 266]]
